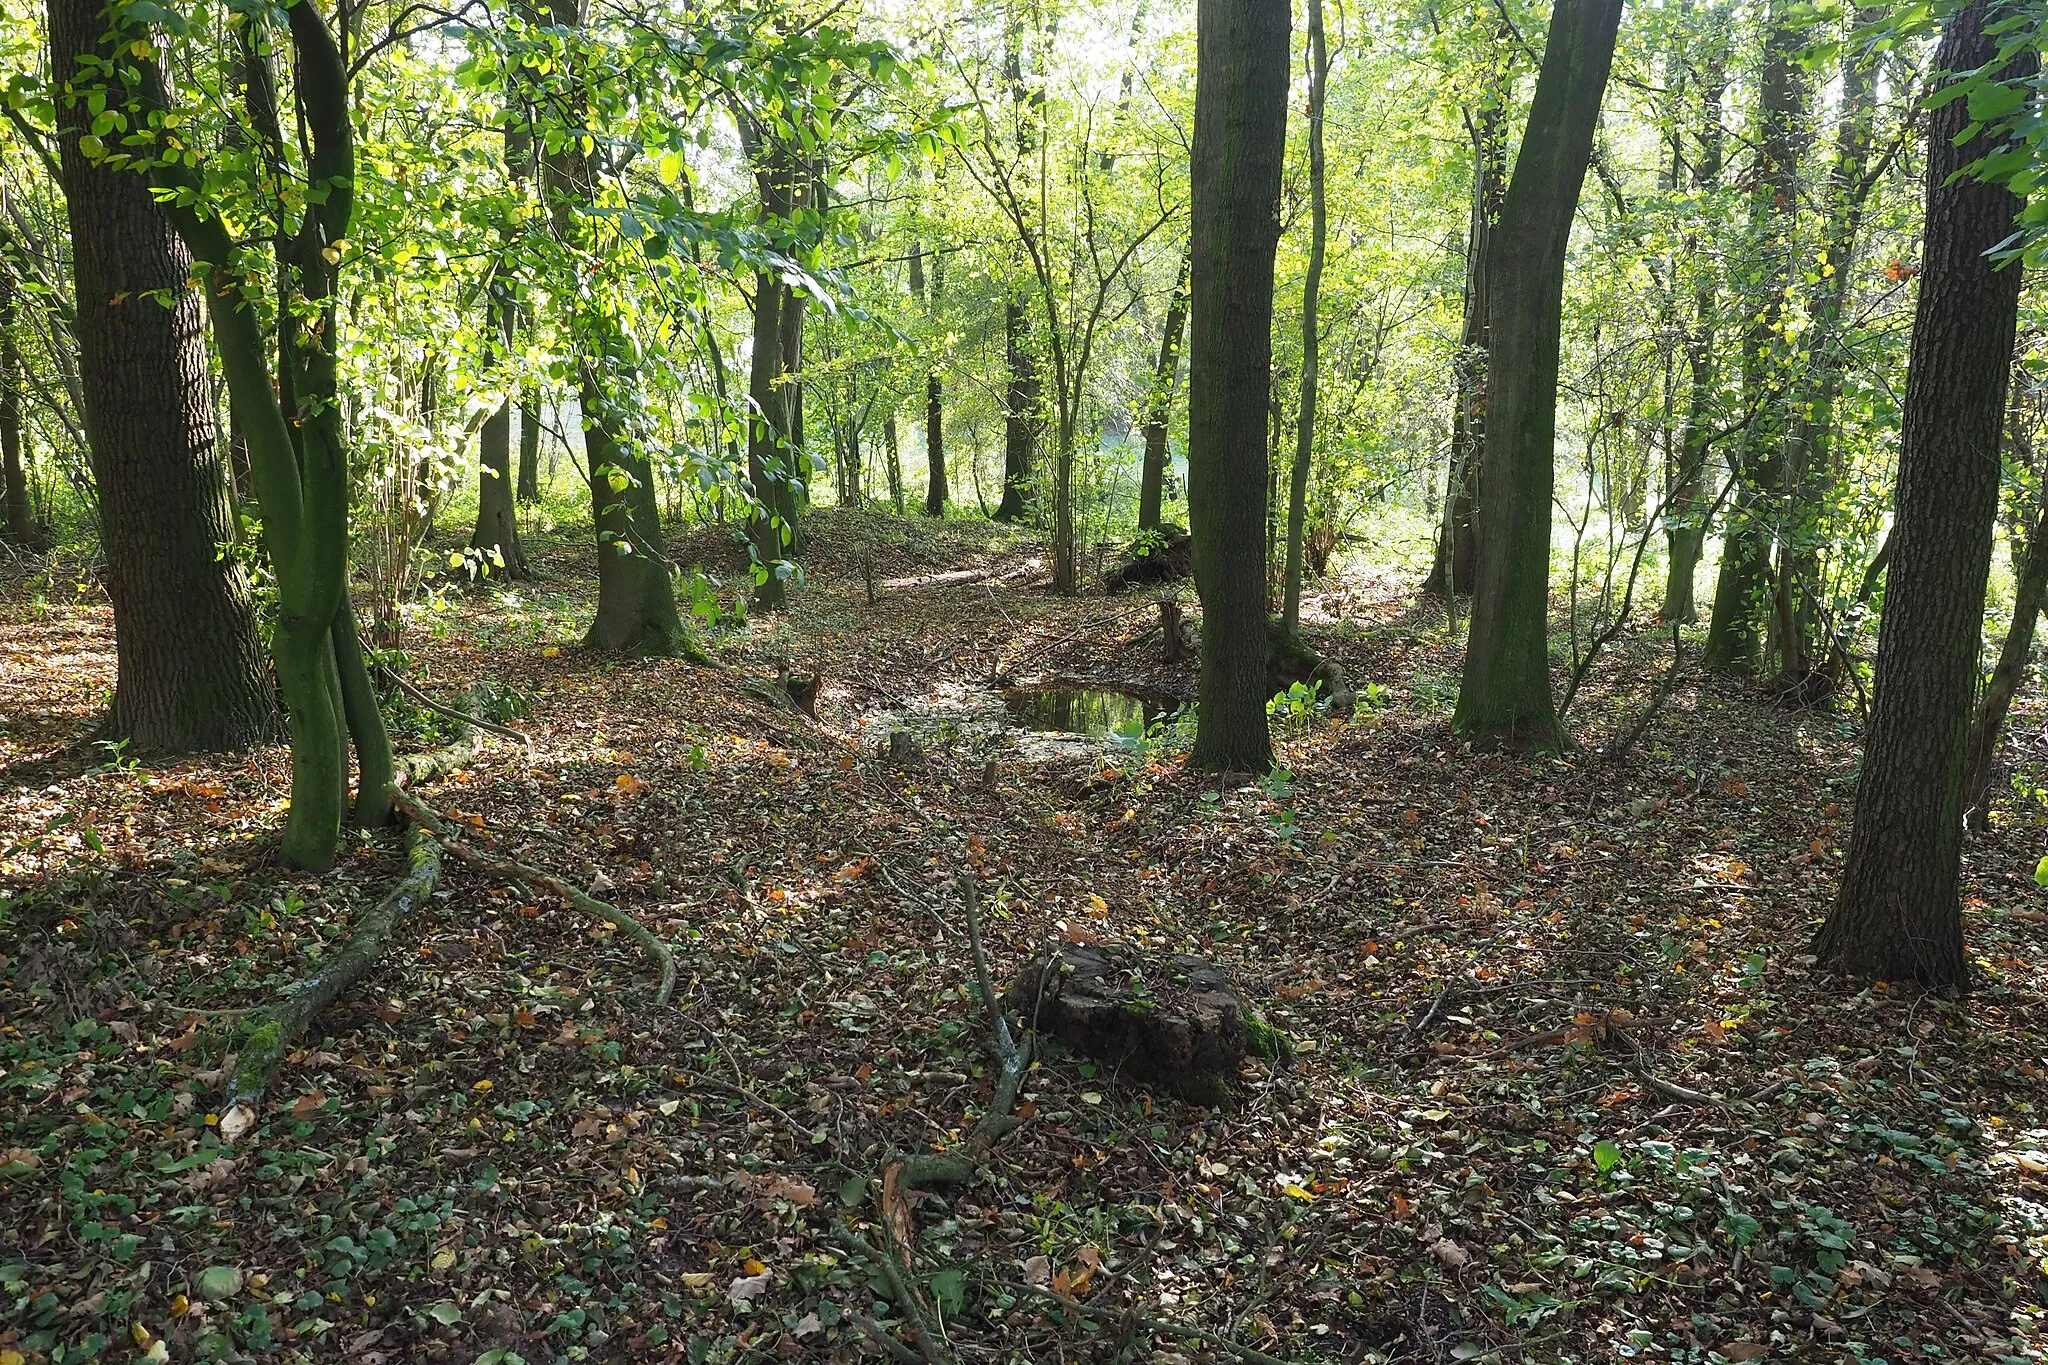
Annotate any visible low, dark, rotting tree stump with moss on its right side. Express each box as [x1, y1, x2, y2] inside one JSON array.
[[1004, 943, 1268, 1105]]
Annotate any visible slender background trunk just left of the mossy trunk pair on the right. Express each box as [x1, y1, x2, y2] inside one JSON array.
[[1657, 37, 1729, 624]]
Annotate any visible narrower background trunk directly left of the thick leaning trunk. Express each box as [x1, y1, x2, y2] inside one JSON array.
[[1423, 96, 1507, 596]]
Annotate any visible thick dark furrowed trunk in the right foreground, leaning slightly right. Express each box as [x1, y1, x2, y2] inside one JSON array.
[[1815, 0, 2036, 990]]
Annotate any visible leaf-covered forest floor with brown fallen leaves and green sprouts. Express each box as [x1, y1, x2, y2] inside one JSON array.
[[0, 514, 2048, 1365]]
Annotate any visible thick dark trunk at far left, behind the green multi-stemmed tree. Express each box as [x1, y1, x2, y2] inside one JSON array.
[[49, 0, 274, 753]]
